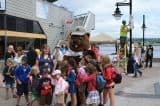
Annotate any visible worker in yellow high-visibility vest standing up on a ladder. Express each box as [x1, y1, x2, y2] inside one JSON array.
[[120, 20, 129, 48]]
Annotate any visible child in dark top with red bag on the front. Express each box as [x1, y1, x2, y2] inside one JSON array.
[[38, 67, 52, 106]]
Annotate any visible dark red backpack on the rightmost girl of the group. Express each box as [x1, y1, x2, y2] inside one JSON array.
[[112, 67, 122, 84]]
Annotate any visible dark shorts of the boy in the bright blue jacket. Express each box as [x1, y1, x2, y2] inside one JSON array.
[[17, 83, 28, 96]]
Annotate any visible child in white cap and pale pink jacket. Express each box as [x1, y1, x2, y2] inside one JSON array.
[[52, 70, 68, 106]]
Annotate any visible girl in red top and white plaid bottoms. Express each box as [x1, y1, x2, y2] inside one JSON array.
[[83, 63, 100, 106]]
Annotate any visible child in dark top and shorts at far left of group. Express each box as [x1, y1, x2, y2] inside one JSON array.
[[3, 58, 16, 100]]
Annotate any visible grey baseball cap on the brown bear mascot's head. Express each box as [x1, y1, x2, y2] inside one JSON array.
[[71, 26, 89, 35]]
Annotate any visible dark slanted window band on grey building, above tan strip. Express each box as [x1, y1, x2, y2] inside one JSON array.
[[0, 14, 44, 34]]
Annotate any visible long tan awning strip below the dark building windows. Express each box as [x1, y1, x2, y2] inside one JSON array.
[[0, 30, 47, 39]]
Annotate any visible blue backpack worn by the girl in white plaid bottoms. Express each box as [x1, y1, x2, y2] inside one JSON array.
[[96, 74, 106, 92]]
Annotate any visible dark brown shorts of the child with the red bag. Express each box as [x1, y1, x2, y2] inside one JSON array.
[[40, 94, 52, 105]]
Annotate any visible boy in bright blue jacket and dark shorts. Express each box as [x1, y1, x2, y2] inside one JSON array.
[[15, 56, 30, 106]]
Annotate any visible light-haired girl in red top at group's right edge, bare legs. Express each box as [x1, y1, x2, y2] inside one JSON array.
[[102, 56, 115, 106]]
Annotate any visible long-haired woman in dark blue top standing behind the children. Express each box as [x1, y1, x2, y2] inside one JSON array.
[[36, 44, 56, 73]]
